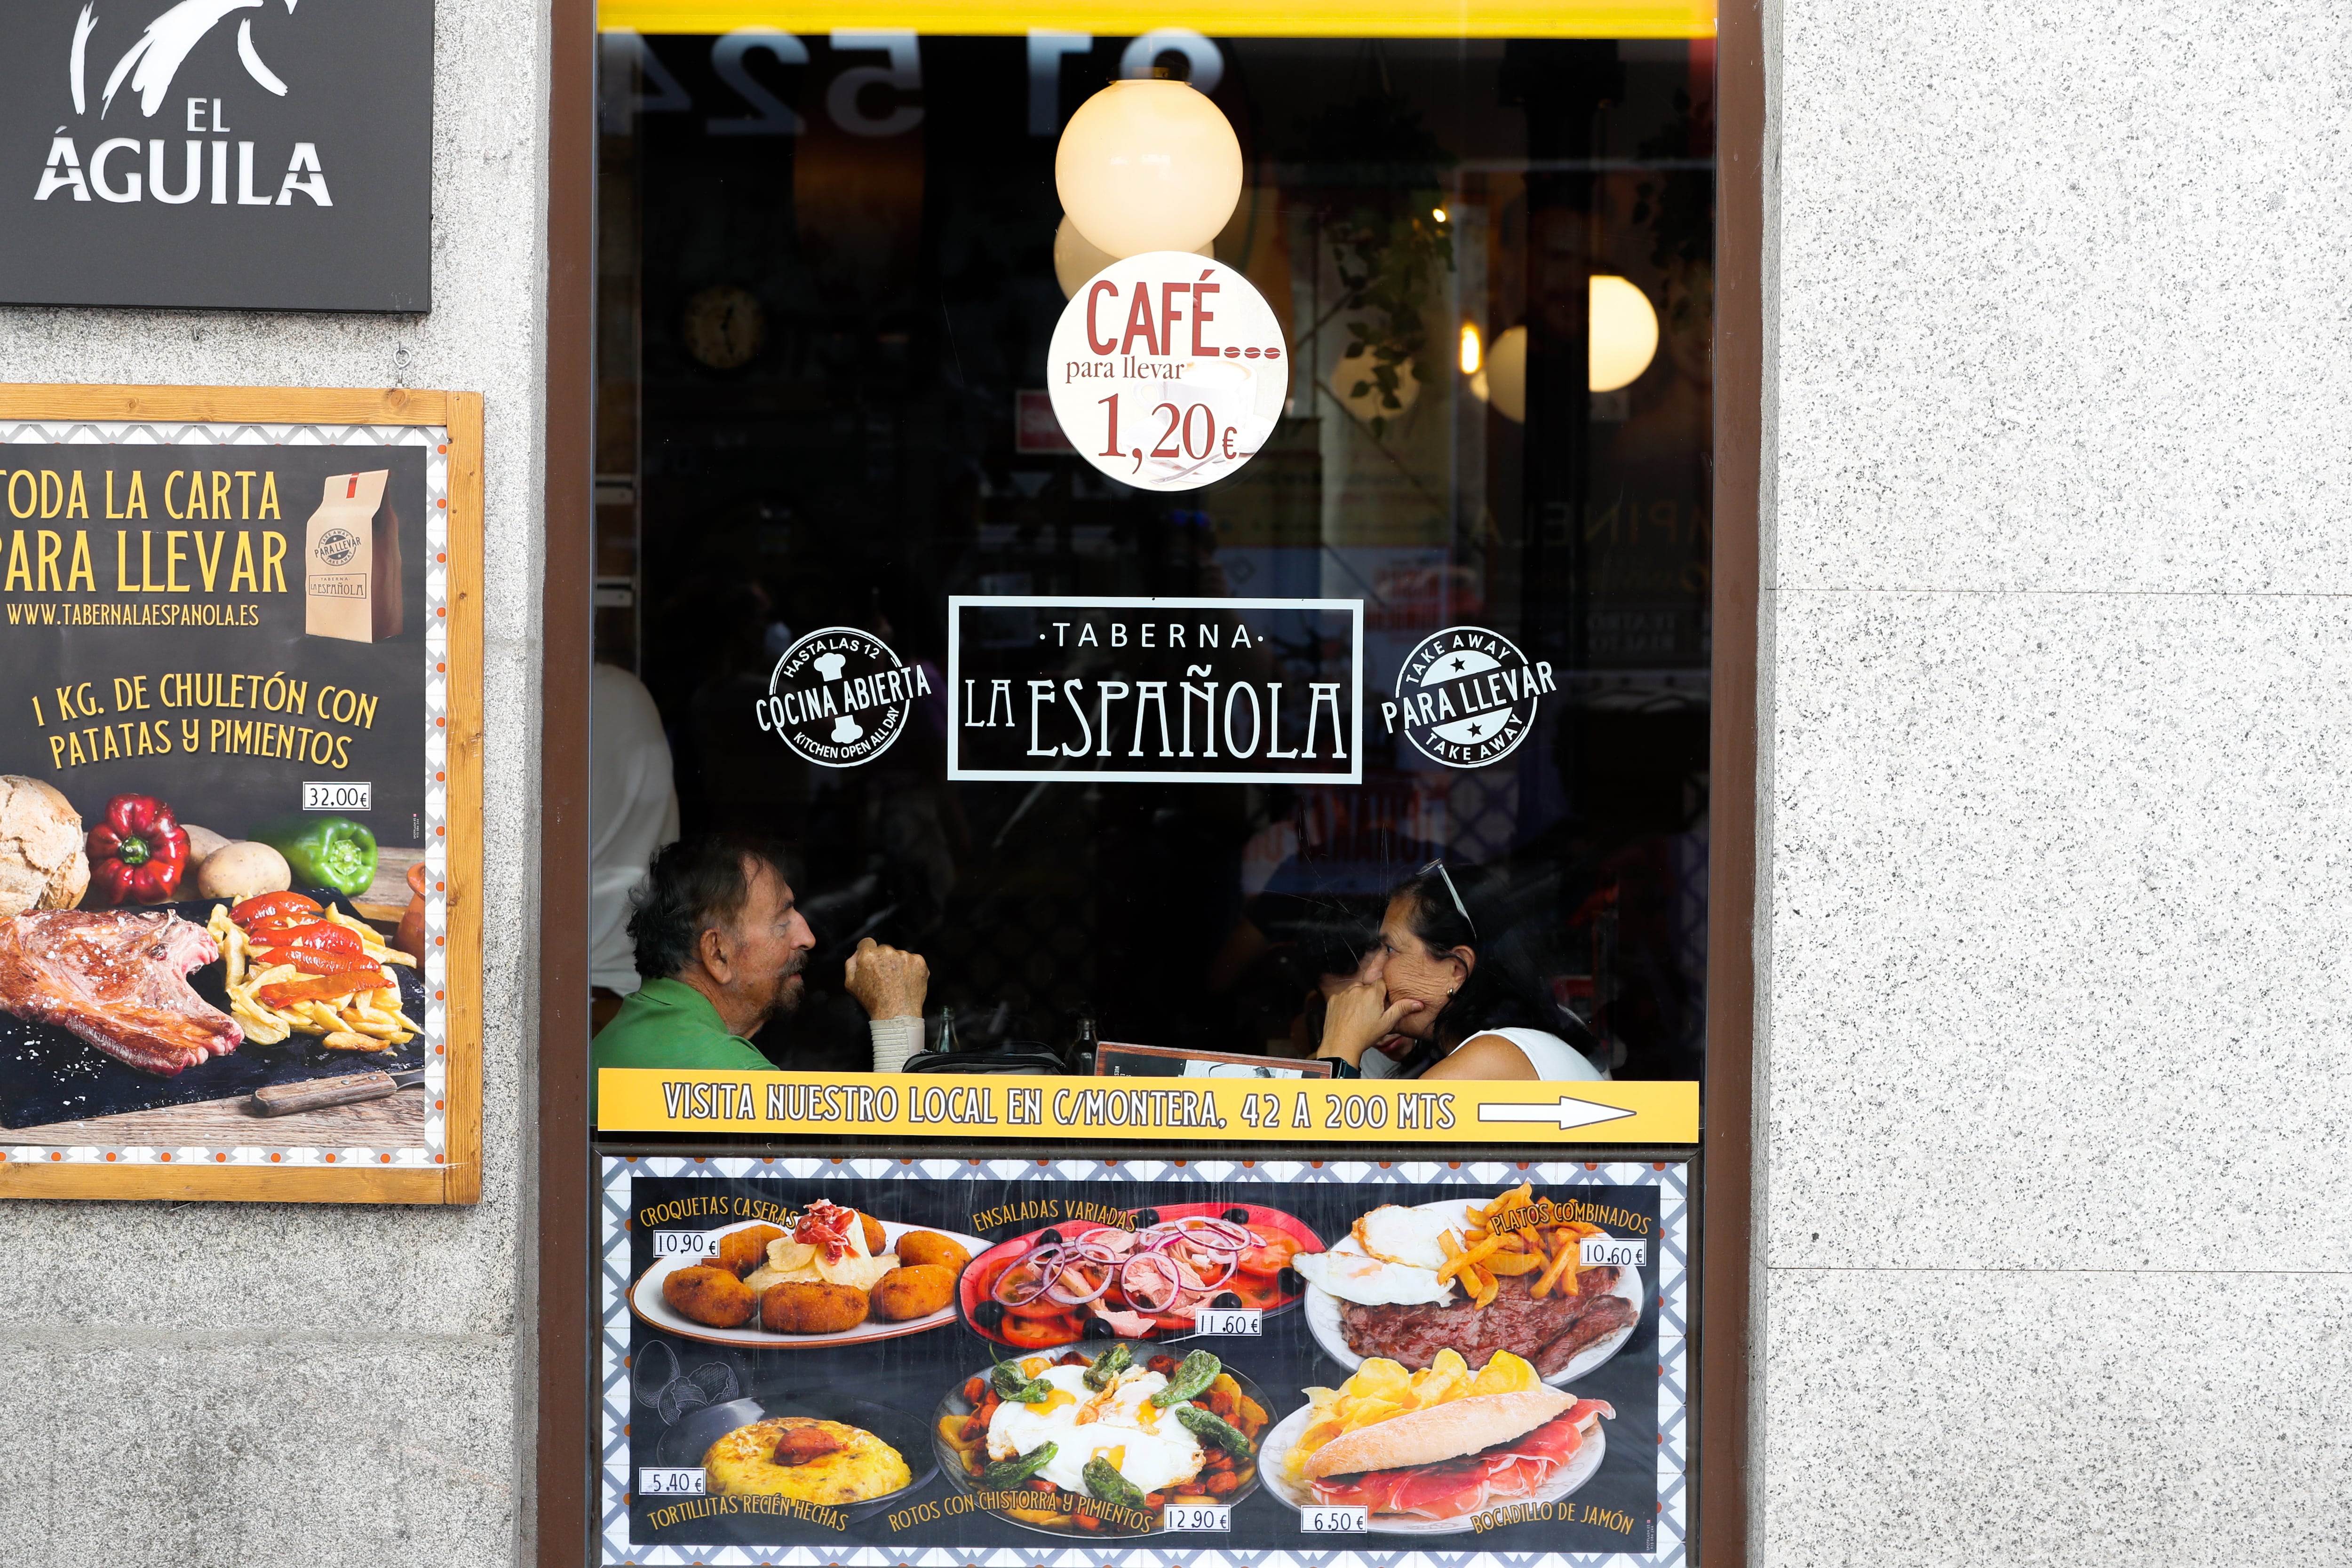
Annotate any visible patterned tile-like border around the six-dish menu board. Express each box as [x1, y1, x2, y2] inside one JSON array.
[[597, 1154, 1693, 1568]]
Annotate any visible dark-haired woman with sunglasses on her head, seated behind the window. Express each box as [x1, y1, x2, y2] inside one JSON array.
[[1315, 860, 1606, 1079]]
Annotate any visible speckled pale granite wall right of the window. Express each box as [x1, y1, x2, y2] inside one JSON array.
[[1752, 0, 2352, 1568]]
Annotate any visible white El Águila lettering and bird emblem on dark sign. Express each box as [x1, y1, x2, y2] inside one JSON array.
[[33, 0, 334, 207]]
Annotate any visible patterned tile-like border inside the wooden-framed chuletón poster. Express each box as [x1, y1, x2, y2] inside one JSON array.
[[0, 421, 449, 1166]]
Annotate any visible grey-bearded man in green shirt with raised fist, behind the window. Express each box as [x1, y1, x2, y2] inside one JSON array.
[[588, 834, 929, 1119]]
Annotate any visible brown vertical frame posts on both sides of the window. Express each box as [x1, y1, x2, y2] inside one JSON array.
[[515, 0, 1766, 1568]]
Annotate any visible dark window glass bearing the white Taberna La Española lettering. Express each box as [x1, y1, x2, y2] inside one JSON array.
[[595, 19, 1715, 1079]]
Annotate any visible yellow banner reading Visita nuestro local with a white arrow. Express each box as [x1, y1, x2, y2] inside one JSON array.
[[597, 1067, 1698, 1145]]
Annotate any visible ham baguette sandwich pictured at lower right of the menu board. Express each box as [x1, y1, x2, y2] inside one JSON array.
[[1305, 1389, 1616, 1519]]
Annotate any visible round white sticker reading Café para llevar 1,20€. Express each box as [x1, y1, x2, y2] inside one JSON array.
[[1047, 252, 1291, 491]]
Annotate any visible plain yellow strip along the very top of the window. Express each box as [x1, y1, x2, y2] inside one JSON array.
[[597, 0, 1715, 38]]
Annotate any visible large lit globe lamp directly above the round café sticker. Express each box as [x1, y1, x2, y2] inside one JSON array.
[[1054, 80, 1242, 259]]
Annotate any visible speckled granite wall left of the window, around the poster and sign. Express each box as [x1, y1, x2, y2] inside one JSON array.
[[0, 0, 548, 1568]]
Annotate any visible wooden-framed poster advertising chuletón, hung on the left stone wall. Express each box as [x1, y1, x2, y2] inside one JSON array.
[[0, 386, 482, 1204]]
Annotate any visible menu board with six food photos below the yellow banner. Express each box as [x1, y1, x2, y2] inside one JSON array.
[[600, 1154, 1691, 1568]]
